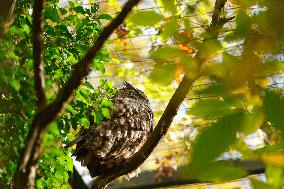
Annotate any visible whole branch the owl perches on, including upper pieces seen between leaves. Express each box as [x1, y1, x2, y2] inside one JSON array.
[[92, 0, 230, 189]]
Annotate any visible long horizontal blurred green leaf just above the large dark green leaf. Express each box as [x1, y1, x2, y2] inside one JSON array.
[[189, 98, 242, 118]]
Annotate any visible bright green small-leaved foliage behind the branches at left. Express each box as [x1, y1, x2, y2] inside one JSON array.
[[0, 0, 115, 188]]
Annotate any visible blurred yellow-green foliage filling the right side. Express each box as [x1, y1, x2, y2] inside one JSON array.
[[125, 0, 284, 188]]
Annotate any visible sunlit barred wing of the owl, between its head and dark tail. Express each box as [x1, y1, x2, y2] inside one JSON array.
[[97, 98, 153, 164]]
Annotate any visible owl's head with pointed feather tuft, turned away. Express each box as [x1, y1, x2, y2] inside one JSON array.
[[118, 81, 149, 102]]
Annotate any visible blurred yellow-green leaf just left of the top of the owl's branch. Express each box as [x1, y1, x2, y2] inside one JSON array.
[[150, 64, 176, 85]]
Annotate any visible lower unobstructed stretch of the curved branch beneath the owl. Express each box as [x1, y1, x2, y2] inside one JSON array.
[[93, 76, 197, 189]]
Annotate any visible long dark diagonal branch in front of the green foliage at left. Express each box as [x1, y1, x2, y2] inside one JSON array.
[[14, 0, 140, 189]]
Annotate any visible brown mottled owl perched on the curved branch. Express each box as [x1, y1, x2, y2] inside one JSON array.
[[68, 82, 154, 177]]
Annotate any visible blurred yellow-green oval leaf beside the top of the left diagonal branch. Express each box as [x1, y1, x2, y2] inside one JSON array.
[[129, 10, 164, 26]]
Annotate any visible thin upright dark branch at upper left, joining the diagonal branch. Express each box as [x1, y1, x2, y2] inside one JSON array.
[[32, 0, 46, 109]]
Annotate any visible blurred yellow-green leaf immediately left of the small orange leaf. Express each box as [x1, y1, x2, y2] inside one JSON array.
[[150, 46, 181, 60]]
